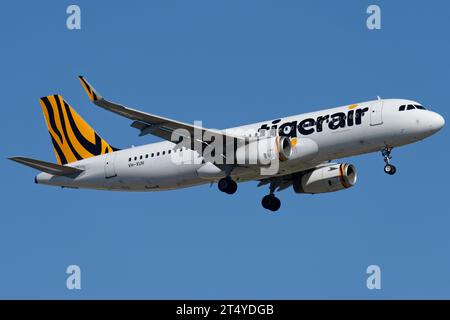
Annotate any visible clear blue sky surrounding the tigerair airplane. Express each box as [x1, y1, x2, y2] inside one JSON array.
[[0, 1, 450, 299]]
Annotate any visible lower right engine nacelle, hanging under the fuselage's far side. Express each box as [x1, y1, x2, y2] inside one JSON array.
[[293, 163, 357, 194]]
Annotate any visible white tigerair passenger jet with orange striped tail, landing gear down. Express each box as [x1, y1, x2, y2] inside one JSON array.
[[9, 76, 445, 212]]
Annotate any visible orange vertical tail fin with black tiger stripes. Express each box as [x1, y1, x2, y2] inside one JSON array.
[[40, 95, 118, 165]]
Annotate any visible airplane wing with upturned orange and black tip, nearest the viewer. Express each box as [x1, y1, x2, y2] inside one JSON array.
[[79, 76, 243, 149]]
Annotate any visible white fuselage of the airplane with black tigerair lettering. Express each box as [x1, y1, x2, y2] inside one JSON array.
[[36, 99, 444, 191]]
